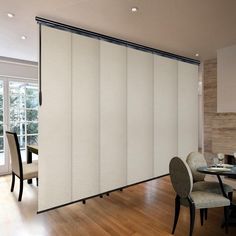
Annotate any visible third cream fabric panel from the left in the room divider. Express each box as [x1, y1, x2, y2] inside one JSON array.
[[100, 41, 127, 192]]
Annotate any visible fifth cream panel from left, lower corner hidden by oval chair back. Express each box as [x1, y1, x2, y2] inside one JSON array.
[[154, 55, 178, 176]]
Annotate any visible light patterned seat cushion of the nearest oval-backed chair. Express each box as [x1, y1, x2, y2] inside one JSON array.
[[181, 191, 230, 209]]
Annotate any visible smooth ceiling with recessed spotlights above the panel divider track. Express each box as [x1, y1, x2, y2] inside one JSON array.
[[0, 0, 236, 61]]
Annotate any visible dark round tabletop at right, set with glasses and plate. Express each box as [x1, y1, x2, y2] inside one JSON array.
[[197, 165, 236, 177]]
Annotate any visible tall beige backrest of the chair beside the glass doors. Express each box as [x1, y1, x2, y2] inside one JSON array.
[[6, 131, 22, 176]]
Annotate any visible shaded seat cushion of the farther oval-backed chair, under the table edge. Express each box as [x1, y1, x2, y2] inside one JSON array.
[[192, 181, 233, 194]]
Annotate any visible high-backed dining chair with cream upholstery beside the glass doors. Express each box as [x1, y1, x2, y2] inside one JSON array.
[[6, 131, 38, 201]]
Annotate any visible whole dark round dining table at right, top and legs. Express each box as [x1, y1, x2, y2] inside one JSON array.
[[197, 164, 236, 226]]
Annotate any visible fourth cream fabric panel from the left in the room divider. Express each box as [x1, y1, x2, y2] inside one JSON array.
[[127, 48, 154, 184]]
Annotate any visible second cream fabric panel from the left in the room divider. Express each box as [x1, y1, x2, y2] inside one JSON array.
[[72, 34, 100, 201]]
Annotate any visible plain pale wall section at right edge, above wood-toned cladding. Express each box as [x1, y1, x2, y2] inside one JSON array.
[[217, 45, 236, 112]]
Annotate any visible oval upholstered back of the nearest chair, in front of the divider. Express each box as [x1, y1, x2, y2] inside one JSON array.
[[169, 157, 193, 198]]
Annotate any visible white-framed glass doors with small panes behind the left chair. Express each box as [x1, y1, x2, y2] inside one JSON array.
[[0, 78, 38, 175]]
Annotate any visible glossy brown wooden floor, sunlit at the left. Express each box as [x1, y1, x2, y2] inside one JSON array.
[[0, 176, 236, 236]]
